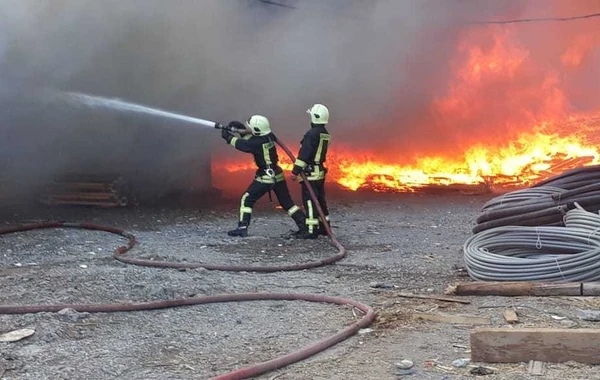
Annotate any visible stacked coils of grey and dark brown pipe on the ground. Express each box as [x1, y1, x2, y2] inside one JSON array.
[[463, 166, 600, 282]]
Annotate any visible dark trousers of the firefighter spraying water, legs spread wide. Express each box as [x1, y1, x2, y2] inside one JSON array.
[[239, 179, 306, 229]]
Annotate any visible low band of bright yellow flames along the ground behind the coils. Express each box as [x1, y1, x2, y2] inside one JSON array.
[[331, 123, 600, 192]]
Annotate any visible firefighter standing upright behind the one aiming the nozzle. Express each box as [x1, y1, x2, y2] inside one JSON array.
[[291, 104, 331, 239]]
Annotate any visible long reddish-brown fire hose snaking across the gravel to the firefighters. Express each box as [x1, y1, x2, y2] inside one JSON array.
[[0, 134, 376, 380]]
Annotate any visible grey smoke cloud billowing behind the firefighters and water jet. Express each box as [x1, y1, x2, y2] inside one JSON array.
[[0, 0, 599, 200]]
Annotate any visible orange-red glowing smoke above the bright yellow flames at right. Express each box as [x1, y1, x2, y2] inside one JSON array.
[[392, 0, 600, 157]]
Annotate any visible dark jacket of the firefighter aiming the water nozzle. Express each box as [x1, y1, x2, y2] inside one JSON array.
[[226, 133, 285, 183]]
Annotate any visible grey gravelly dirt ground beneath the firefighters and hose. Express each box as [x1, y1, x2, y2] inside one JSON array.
[[0, 194, 600, 380]]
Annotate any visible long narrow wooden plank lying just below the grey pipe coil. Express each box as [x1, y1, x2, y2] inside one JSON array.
[[446, 281, 582, 297]]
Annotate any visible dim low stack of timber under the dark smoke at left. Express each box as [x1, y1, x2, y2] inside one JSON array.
[[39, 175, 136, 207]]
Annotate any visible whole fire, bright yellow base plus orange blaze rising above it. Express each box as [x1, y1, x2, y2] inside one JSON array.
[[211, 20, 600, 192]]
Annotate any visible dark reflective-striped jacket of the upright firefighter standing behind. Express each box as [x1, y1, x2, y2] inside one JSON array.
[[292, 124, 331, 181]]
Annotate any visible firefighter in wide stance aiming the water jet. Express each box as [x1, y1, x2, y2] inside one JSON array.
[[221, 115, 307, 237]]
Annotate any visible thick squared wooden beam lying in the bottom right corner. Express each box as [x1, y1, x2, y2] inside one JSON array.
[[471, 328, 600, 364]]
